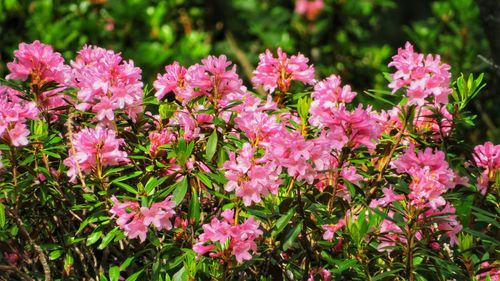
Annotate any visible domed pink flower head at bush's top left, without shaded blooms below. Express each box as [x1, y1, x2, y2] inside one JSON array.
[[6, 40, 70, 85]]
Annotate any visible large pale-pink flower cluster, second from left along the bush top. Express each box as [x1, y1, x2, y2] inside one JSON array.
[[71, 46, 144, 122]]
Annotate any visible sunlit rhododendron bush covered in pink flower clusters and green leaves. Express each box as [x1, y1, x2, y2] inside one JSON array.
[[0, 40, 500, 281]]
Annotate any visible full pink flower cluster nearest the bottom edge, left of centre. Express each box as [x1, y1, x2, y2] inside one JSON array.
[[193, 209, 262, 263]]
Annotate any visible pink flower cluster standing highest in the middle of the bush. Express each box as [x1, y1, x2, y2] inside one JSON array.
[[252, 48, 314, 93]]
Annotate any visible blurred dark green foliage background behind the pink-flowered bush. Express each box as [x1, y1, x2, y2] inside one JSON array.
[[0, 0, 500, 143]]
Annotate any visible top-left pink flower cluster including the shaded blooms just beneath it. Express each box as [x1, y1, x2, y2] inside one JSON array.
[[6, 40, 71, 113]]
